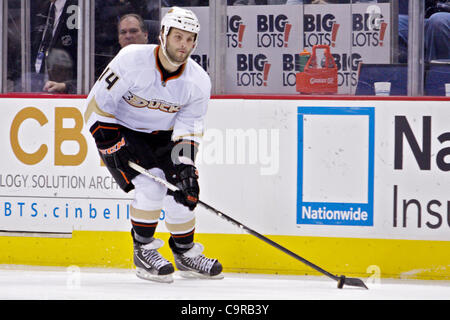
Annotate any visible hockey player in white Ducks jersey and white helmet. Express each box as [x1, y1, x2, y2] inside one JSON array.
[[85, 7, 223, 282]]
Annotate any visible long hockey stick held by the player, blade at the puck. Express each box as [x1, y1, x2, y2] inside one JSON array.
[[128, 161, 369, 289]]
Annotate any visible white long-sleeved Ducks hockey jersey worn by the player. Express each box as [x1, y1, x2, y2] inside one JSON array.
[[84, 44, 211, 142]]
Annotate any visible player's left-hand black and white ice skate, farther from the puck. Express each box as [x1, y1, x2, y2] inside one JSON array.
[[133, 239, 174, 283]]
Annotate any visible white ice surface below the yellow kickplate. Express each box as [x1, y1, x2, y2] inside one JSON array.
[[0, 265, 450, 301]]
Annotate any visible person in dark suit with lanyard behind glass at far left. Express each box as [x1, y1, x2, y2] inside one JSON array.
[[31, 0, 78, 93]]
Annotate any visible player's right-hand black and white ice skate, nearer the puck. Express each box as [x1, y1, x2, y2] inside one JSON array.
[[169, 242, 223, 279]]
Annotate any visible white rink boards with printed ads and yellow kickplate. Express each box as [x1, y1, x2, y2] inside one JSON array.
[[0, 96, 450, 279]]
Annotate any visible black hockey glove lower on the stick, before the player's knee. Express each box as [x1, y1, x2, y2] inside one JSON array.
[[173, 164, 200, 211]]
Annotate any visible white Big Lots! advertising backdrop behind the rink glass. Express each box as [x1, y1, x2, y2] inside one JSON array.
[[176, 3, 392, 94]]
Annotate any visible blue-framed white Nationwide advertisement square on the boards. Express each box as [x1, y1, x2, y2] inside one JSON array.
[[297, 107, 375, 226]]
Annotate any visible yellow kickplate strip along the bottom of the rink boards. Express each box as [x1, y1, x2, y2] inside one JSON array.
[[0, 231, 450, 280]]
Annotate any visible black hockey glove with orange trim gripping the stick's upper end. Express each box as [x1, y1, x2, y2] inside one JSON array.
[[90, 122, 137, 175]]
